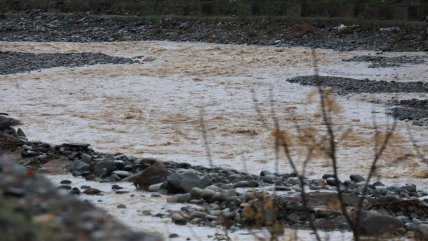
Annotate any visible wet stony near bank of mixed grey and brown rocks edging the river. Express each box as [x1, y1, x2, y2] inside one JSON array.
[[1, 117, 428, 238]]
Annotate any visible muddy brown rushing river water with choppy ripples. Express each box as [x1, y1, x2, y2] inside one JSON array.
[[0, 42, 428, 240]]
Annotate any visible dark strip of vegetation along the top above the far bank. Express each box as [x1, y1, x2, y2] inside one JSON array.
[[0, 0, 428, 21]]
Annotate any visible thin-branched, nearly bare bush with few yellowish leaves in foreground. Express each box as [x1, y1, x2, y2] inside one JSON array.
[[242, 50, 397, 241]]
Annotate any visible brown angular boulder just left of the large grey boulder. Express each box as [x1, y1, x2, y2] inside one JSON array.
[[123, 161, 170, 189]]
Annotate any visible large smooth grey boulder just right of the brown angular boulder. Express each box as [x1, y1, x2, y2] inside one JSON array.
[[167, 169, 212, 193]]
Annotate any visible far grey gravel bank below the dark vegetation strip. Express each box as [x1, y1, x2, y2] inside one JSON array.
[[0, 11, 428, 51]]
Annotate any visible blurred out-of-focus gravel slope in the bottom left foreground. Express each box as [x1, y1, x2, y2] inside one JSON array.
[[0, 156, 161, 241]]
